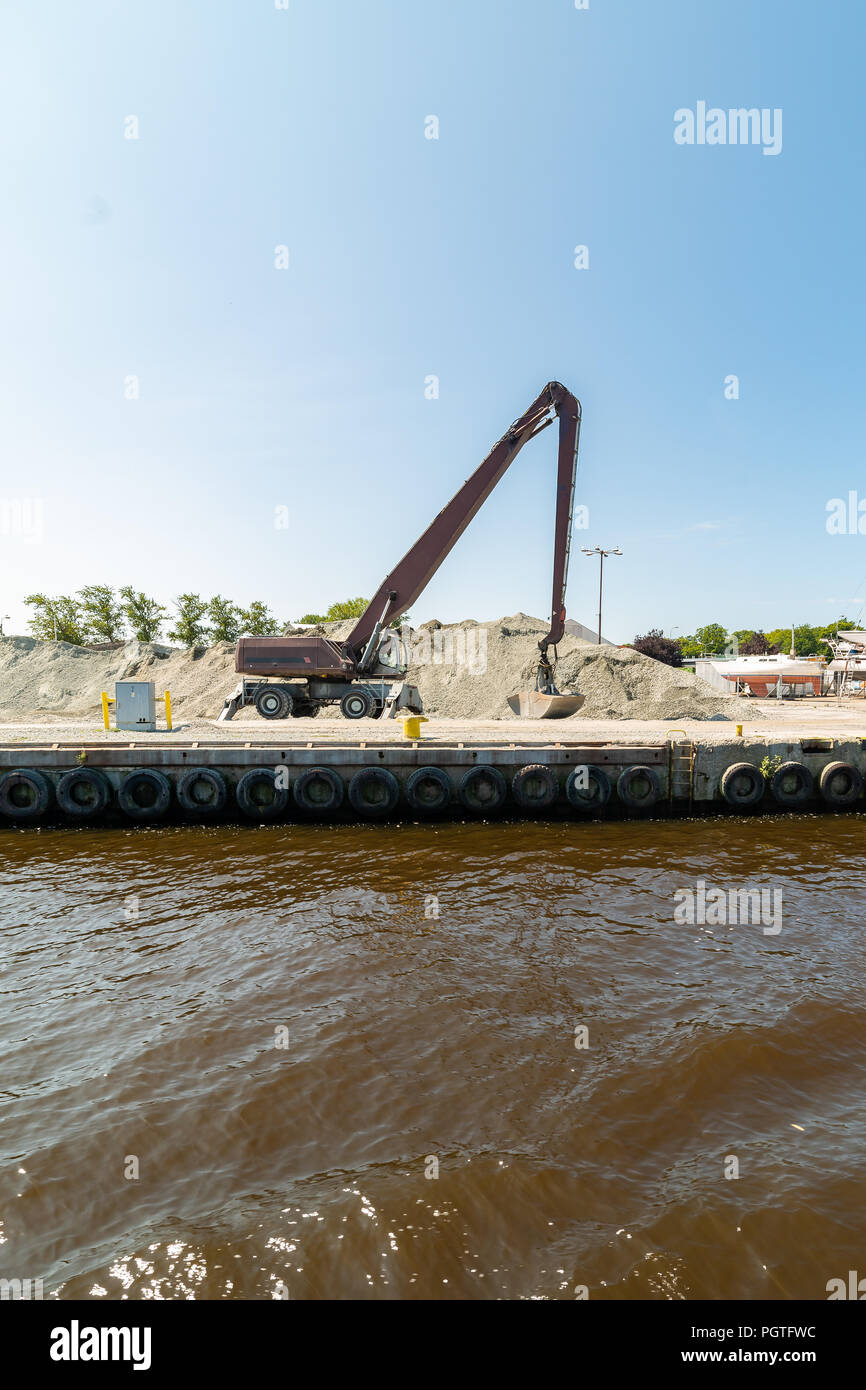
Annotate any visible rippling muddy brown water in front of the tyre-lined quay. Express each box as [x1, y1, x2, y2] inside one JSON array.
[[0, 816, 866, 1300]]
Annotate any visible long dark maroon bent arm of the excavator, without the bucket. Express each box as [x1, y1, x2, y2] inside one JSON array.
[[345, 381, 581, 672]]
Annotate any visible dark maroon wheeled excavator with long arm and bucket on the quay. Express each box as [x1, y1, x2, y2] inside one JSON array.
[[220, 381, 584, 720]]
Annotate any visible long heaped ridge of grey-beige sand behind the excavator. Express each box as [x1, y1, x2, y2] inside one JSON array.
[[0, 613, 756, 723]]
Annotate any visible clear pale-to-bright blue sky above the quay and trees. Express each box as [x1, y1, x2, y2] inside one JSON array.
[[0, 0, 866, 641]]
